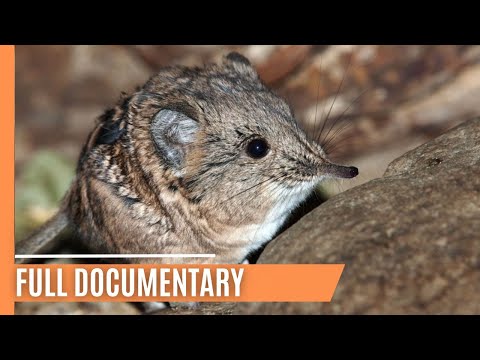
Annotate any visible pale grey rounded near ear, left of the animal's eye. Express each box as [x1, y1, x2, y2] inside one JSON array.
[[151, 109, 199, 171]]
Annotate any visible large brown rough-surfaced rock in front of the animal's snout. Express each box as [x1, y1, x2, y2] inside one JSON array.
[[235, 118, 480, 314]]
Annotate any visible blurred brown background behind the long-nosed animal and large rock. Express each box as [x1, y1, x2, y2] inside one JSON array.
[[15, 45, 480, 312]]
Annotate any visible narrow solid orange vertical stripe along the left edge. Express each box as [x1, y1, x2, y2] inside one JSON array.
[[0, 45, 15, 315]]
